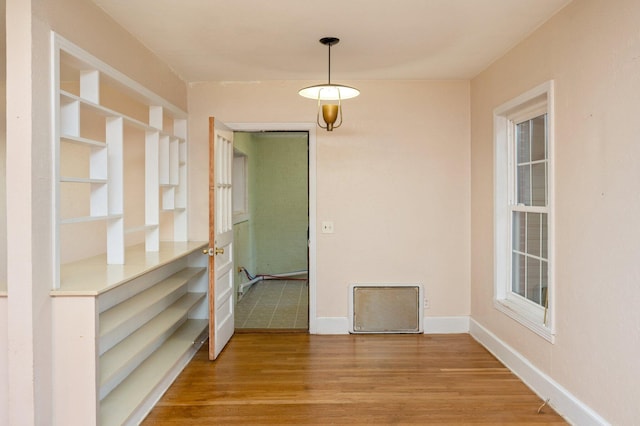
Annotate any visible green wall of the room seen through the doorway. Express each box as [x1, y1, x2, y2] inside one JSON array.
[[234, 132, 309, 293]]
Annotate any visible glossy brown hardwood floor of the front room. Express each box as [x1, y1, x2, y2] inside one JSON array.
[[142, 334, 566, 426]]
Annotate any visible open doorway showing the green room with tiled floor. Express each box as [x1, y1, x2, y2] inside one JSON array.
[[233, 130, 310, 332]]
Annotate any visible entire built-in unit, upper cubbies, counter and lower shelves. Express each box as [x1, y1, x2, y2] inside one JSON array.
[[51, 34, 208, 425]]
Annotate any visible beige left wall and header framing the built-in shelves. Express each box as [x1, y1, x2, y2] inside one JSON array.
[[0, 0, 186, 425]]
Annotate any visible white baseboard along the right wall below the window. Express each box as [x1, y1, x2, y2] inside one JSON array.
[[469, 319, 610, 426]]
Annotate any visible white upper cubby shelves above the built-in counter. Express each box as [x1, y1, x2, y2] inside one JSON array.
[[54, 39, 187, 274]]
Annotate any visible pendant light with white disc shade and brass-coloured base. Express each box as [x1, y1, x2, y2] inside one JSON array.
[[298, 37, 360, 132]]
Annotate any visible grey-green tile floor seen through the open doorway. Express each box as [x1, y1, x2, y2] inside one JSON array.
[[235, 280, 309, 330]]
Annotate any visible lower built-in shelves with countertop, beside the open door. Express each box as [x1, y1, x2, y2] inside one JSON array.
[[52, 242, 208, 426]]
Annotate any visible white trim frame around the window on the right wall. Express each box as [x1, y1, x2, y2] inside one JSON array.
[[493, 81, 555, 343]]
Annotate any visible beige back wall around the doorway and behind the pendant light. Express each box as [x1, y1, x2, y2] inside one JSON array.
[[189, 81, 470, 318]]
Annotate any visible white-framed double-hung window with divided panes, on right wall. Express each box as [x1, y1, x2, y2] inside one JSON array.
[[494, 82, 554, 341]]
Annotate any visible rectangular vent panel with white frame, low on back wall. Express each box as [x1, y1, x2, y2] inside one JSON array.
[[349, 284, 423, 333]]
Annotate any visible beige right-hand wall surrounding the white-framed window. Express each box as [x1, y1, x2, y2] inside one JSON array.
[[471, 0, 640, 425]]
